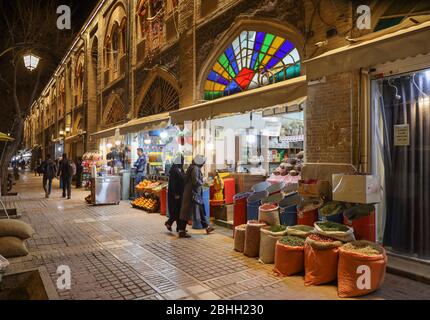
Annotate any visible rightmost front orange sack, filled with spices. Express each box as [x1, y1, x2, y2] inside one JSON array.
[[338, 240, 387, 298]]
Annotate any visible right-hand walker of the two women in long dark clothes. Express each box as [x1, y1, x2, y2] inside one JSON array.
[[178, 155, 214, 238]]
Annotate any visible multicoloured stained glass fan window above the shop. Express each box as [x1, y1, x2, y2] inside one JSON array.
[[204, 31, 301, 100]]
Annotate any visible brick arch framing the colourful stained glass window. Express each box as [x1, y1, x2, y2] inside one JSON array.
[[196, 18, 305, 97]]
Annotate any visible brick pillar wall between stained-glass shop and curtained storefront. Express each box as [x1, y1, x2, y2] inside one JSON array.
[[305, 72, 358, 163]]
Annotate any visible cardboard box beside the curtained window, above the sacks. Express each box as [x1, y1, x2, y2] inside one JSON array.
[[332, 174, 381, 204]]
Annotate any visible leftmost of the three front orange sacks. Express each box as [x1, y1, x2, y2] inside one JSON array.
[[273, 241, 304, 276]]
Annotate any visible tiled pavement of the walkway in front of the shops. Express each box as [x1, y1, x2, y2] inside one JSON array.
[[4, 174, 430, 300]]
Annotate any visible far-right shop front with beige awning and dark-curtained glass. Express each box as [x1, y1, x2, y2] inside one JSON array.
[[307, 21, 430, 260]]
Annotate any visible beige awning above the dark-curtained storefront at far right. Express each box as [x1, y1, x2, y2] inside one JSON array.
[[304, 19, 430, 80]]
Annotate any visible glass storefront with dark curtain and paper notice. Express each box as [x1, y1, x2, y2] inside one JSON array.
[[372, 70, 430, 259]]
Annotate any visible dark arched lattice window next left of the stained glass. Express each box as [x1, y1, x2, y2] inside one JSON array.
[[134, 67, 179, 118]]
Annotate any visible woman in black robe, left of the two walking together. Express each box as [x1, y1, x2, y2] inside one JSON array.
[[165, 155, 185, 232]]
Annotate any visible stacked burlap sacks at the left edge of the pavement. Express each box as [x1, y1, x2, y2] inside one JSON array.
[[0, 219, 35, 258]]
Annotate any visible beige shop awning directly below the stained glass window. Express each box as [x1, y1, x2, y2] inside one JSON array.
[[170, 76, 307, 124]]
